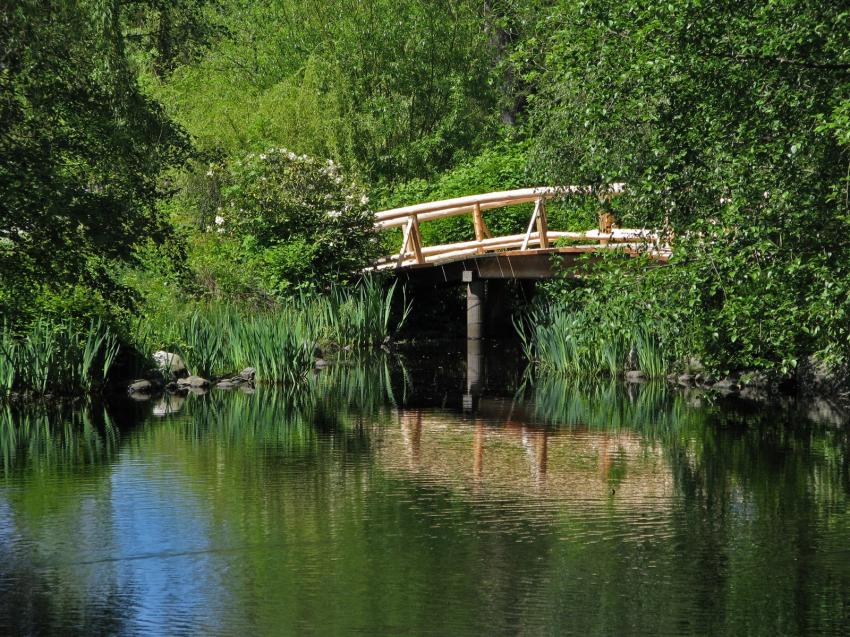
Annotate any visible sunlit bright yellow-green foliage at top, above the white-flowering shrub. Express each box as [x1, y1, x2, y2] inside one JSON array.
[[151, 0, 494, 178]]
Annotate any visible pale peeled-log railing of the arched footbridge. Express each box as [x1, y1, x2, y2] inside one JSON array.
[[375, 184, 662, 269]]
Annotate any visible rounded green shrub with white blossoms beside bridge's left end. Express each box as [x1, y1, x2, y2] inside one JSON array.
[[210, 148, 378, 296]]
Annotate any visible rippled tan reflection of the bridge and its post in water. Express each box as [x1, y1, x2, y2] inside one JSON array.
[[378, 340, 673, 504]]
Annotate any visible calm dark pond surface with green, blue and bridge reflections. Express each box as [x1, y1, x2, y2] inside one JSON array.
[[0, 351, 850, 635]]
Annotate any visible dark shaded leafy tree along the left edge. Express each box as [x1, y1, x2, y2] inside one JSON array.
[[0, 0, 190, 326]]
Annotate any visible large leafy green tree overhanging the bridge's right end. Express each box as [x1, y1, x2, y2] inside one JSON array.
[[532, 0, 850, 372]]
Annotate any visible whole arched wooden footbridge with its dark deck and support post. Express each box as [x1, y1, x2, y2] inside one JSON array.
[[374, 184, 670, 338]]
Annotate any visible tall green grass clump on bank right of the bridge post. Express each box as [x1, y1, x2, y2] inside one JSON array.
[[516, 306, 673, 377]]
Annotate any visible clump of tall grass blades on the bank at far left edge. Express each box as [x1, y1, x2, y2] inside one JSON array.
[[0, 320, 119, 396]]
